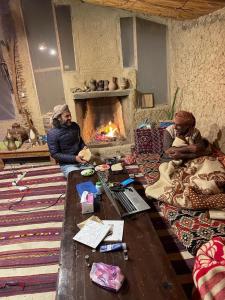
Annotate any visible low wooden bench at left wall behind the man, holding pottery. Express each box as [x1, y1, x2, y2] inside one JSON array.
[[0, 143, 53, 168]]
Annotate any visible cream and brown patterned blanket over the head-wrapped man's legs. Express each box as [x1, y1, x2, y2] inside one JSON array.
[[145, 138, 225, 209]]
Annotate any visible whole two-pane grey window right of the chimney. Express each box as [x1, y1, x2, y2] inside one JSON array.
[[120, 17, 168, 105]]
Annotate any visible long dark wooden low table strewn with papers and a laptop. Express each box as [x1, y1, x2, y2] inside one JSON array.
[[56, 171, 186, 300]]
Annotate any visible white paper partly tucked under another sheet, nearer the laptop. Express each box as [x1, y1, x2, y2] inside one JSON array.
[[102, 220, 124, 242]]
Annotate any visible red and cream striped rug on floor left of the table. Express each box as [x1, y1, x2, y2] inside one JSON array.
[[0, 164, 66, 300]]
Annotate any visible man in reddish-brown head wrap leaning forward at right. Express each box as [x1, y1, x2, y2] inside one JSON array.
[[163, 111, 209, 159]]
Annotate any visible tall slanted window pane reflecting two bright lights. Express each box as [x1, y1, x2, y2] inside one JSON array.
[[21, 0, 65, 114]]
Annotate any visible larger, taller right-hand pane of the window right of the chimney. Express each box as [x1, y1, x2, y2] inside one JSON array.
[[137, 18, 168, 105]]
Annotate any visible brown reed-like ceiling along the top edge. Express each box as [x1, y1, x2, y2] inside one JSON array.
[[81, 0, 225, 20]]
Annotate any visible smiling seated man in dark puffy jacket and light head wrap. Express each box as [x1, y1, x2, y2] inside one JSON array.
[[47, 104, 86, 177]]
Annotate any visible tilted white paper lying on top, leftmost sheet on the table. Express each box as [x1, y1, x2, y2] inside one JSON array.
[[73, 221, 110, 248]]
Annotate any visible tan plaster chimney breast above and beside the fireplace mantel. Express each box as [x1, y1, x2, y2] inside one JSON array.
[[54, 0, 136, 124]]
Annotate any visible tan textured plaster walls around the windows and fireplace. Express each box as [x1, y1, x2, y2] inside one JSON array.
[[4, 0, 225, 150]]
